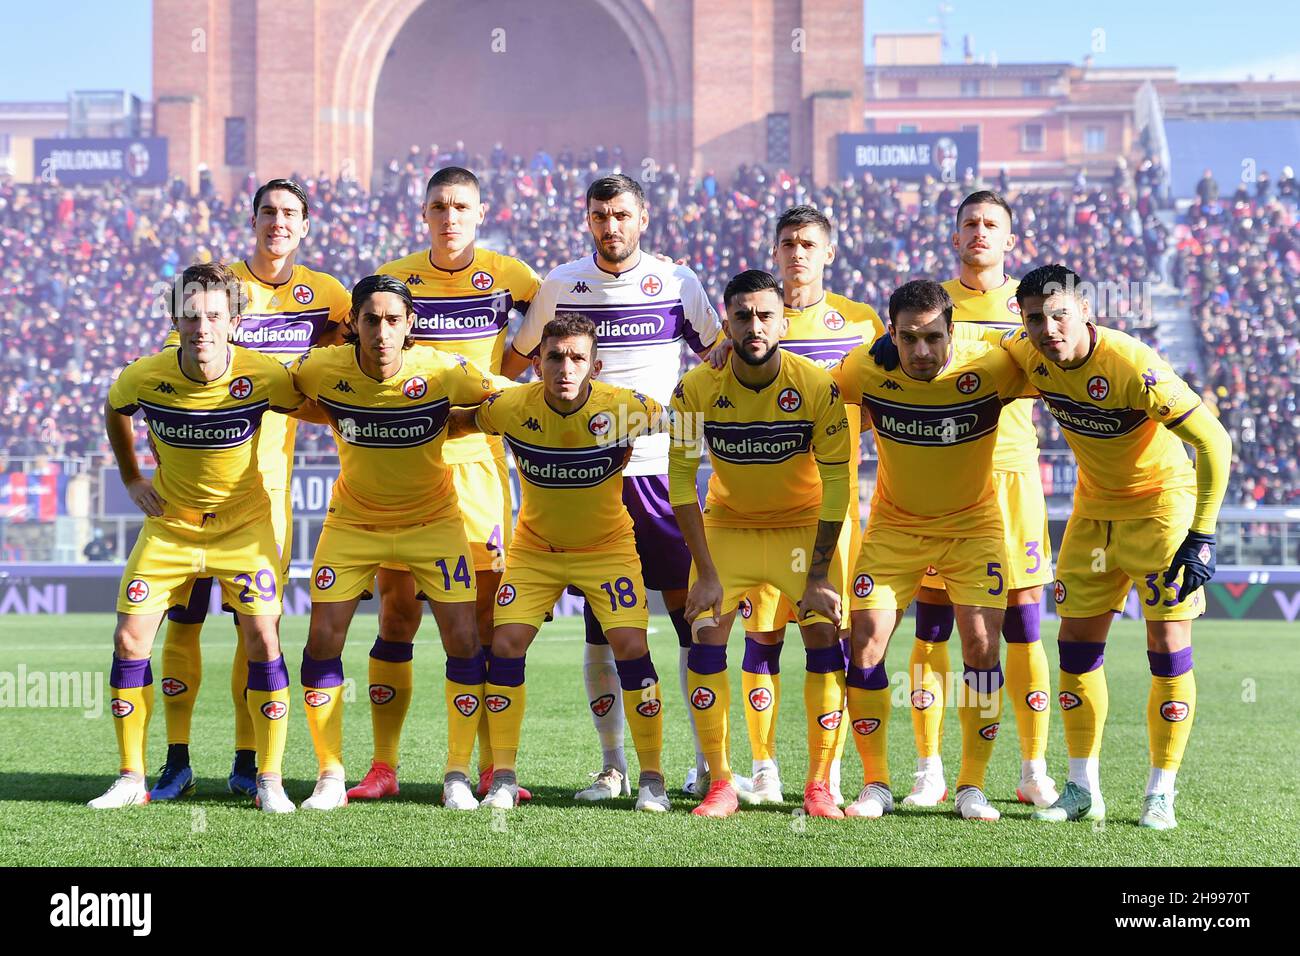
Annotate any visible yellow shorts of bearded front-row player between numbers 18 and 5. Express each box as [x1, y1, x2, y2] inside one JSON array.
[[690, 524, 833, 631]]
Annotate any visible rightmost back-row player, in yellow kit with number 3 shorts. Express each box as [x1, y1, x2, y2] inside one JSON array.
[[904, 190, 1057, 806]]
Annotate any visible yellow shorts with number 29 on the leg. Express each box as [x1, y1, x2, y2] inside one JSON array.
[[117, 497, 285, 617]]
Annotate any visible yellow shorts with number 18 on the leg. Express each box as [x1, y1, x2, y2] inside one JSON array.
[[493, 537, 650, 631]]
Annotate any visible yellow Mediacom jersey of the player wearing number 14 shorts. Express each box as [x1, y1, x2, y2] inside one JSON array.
[[294, 345, 497, 528]]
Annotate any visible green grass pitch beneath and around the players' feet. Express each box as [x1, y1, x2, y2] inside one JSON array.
[[0, 614, 1300, 866]]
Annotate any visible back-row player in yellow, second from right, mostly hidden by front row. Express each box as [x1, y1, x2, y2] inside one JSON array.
[[733, 206, 885, 804]]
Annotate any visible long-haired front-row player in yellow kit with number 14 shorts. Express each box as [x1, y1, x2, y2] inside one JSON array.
[[294, 276, 506, 810]]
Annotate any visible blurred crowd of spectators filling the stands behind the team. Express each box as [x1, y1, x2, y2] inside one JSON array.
[[0, 143, 1300, 505]]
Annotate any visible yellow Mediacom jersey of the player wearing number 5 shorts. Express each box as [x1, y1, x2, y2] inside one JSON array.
[[832, 338, 1032, 538]]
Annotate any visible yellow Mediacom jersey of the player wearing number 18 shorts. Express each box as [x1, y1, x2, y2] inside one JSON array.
[[476, 380, 663, 551]]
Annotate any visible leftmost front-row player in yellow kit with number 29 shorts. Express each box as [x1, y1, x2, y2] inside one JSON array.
[[90, 263, 303, 813]]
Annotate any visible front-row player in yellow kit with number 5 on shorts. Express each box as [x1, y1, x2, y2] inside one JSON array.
[[835, 278, 1031, 821]]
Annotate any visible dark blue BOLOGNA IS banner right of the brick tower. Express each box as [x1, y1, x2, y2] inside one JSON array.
[[840, 133, 979, 182]]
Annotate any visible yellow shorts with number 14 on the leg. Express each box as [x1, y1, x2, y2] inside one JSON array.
[[312, 516, 477, 604]]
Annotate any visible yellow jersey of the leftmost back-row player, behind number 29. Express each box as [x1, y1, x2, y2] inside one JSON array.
[[164, 261, 352, 492]]
